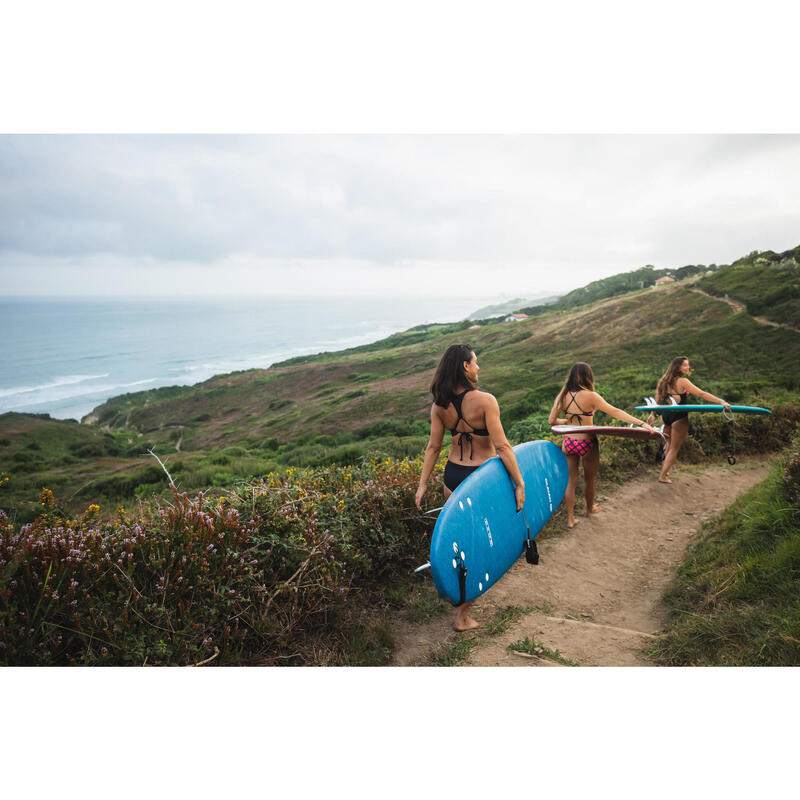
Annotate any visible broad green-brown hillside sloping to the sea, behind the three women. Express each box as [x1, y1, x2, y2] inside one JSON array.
[[0, 268, 800, 519]]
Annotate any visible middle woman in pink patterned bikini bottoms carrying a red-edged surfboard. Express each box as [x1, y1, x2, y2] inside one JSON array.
[[550, 361, 653, 528]]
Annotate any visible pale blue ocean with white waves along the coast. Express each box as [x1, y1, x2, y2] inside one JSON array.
[[0, 297, 480, 420]]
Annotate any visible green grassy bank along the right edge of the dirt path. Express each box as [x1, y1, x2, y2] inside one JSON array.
[[651, 438, 800, 666]]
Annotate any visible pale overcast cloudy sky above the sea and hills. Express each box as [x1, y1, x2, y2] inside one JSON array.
[[0, 135, 800, 301]]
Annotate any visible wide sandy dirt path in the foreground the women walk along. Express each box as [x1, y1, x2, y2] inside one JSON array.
[[392, 459, 769, 667]]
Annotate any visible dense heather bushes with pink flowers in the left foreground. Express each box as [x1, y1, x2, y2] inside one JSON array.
[[0, 459, 441, 665]]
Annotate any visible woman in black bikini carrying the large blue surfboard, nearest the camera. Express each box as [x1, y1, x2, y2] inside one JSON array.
[[416, 344, 525, 631]]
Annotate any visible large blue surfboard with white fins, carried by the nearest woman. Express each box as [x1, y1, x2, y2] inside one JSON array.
[[430, 441, 569, 605]]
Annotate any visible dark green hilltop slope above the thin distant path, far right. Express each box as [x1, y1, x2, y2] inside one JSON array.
[[697, 247, 800, 328]]
